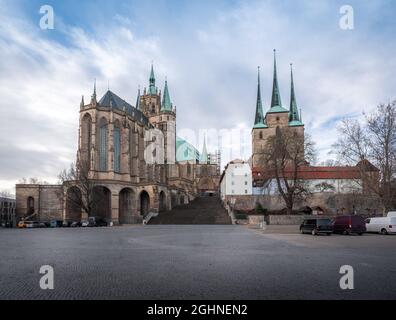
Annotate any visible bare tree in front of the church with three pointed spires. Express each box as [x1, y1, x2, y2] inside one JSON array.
[[263, 128, 315, 214]]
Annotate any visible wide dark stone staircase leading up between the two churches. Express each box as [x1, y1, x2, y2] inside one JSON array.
[[149, 197, 231, 225]]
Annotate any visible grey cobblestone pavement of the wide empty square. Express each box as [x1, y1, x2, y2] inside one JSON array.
[[0, 225, 396, 299]]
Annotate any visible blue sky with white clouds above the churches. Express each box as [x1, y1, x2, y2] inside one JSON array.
[[0, 0, 396, 193]]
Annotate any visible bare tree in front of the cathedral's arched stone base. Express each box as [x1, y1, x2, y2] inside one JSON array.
[[58, 161, 105, 216]]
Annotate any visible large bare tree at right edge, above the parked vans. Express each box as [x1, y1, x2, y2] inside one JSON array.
[[333, 101, 396, 211]]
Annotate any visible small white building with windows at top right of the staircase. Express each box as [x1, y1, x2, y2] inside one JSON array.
[[220, 160, 252, 200]]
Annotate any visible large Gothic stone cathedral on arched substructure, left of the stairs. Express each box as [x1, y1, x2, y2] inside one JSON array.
[[16, 66, 220, 224]]
